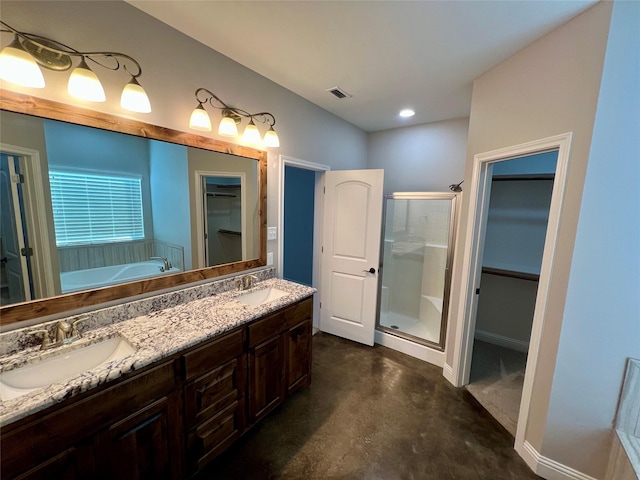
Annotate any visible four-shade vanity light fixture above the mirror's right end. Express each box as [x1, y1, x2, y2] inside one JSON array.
[[189, 88, 280, 147]]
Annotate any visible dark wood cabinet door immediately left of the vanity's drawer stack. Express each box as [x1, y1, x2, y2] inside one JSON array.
[[94, 393, 183, 480]]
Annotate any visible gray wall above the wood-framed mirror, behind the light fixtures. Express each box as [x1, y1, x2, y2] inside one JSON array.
[[2, 1, 367, 270]]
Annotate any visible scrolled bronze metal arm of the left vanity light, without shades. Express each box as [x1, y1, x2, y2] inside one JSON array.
[[0, 21, 142, 79]]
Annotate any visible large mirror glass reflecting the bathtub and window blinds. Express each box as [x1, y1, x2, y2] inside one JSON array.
[[0, 111, 261, 306]]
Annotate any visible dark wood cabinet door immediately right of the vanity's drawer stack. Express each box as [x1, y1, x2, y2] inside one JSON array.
[[249, 335, 284, 422]]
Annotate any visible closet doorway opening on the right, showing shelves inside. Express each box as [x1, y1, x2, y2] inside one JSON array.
[[466, 150, 558, 436]]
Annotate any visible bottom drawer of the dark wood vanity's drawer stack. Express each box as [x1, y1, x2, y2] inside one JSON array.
[[188, 399, 245, 471]]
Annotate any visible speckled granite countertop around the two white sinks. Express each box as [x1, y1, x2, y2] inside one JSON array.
[[0, 278, 315, 426]]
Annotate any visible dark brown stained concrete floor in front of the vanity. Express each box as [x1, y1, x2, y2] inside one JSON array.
[[198, 333, 539, 480]]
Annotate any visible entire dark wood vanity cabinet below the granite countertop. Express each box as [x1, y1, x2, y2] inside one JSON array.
[[0, 298, 313, 480]]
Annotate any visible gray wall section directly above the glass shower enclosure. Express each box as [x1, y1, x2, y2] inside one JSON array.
[[367, 118, 469, 193]]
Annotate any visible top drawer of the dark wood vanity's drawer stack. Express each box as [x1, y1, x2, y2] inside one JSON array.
[[182, 329, 243, 380]]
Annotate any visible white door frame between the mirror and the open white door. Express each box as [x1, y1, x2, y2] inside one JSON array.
[[276, 155, 331, 329]]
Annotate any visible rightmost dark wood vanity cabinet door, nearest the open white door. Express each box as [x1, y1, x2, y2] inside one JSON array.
[[285, 318, 312, 395]]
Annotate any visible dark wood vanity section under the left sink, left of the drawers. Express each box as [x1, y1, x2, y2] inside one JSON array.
[[1, 361, 183, 480]]
